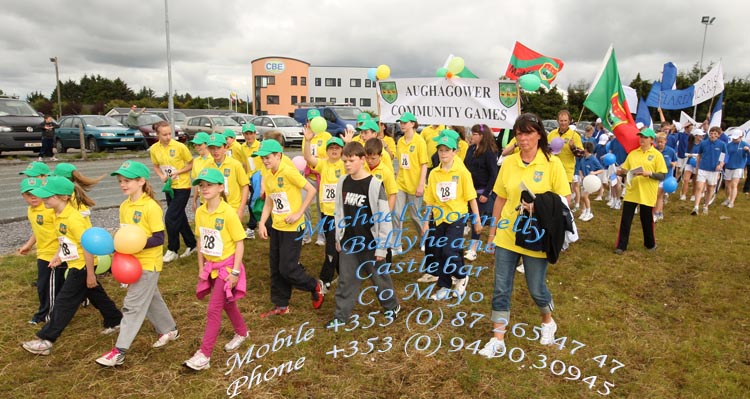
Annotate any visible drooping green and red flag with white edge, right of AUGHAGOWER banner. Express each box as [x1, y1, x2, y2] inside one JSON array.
[[583, 46, 639, 152]]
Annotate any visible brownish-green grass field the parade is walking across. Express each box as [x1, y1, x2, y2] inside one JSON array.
[[0, 193, 750, 398]]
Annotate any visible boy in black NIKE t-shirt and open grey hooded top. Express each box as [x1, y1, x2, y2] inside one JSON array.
[[326, 142, 401, 329]]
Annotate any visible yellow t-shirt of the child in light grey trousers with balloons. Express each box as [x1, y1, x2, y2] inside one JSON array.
[[120, 194, 166, 272]]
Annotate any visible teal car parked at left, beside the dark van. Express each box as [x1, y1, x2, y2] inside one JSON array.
[[55, 115, 145, 154]]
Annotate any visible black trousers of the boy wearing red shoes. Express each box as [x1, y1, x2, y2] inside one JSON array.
[[266, 217, 318, 307]]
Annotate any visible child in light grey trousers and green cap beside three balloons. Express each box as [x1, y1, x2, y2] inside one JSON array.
[[96, 161, 180, 367]]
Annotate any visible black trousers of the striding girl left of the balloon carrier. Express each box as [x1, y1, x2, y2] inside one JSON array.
[[36, 268, 122, 342]]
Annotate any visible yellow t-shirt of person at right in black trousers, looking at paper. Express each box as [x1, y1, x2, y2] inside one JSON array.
[[622, 147, 667, 206]]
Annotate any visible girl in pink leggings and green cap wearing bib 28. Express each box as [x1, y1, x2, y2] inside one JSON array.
[[185, 168, 248, 370]]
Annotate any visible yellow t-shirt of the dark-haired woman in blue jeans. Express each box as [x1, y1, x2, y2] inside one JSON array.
[[492, 150, 570, 258]]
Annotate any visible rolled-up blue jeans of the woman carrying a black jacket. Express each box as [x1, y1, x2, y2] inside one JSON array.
[[491, 247, 554, 325]]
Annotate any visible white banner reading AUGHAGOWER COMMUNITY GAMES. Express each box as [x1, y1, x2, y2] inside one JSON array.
[[378, 78, 520, 128]]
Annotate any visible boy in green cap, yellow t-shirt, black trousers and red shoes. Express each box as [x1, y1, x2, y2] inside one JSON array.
[[253, 140, 323, 318]]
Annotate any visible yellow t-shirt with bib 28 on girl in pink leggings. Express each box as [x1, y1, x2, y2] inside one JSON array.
[[195, 200, 246, 262]]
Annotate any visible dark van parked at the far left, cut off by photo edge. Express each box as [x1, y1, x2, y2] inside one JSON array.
[[0, 96, 44, 152]]
